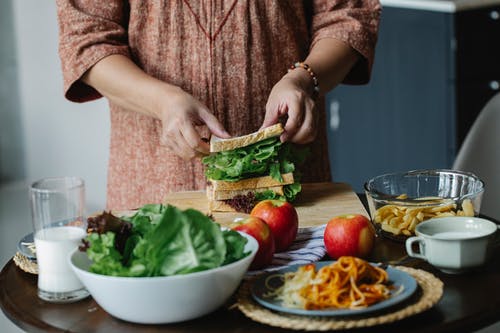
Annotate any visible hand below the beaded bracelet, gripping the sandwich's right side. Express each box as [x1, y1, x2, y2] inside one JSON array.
[[262, 68, 318, 144]]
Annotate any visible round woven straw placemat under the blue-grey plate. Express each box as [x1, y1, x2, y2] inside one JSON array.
[[236, 266, 443, 331]]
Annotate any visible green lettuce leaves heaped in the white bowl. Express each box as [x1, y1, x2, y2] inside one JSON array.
[[86, 205, 252, 276]]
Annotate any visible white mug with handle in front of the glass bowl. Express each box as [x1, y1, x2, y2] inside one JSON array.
[[406, 216, 498, 274]]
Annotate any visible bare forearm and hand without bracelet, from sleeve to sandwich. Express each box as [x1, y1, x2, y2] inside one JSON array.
[[82, 54, 230, 159]]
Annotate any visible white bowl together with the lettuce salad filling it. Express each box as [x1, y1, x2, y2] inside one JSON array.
[[69, 204, 258, 324]]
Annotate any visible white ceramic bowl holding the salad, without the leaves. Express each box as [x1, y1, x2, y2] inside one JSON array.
[[69, 233, 258, 324]]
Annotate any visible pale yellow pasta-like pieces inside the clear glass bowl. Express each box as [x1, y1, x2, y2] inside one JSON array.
[[373, 194, 474, 236]]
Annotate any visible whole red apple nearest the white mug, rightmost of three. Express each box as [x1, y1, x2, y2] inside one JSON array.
[[323, 214, 375, 259]]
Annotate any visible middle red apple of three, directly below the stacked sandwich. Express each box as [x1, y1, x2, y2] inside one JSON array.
[[250, 200, 299, 252]]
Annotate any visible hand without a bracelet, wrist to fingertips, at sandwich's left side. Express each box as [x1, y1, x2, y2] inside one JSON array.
[[157, 87, 230, 159]]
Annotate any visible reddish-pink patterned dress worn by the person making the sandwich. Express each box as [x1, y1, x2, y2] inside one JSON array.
[[57, 0, 380, 209]]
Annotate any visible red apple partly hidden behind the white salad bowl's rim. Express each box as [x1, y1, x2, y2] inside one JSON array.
[[230, 216, 275, 269]]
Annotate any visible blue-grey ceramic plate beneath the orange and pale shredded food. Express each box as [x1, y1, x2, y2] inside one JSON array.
[[251, 261, 417, 317]]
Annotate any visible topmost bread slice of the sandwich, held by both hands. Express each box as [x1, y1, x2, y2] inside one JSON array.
[[210, 123, 284, 153]]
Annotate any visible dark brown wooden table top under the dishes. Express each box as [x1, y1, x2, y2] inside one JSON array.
[[0, 185, 500, 333]]
